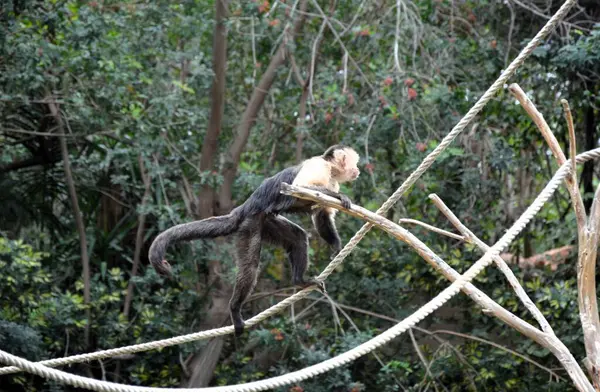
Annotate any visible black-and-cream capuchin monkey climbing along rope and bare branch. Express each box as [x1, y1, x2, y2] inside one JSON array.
[[149, 145, 360, 336]]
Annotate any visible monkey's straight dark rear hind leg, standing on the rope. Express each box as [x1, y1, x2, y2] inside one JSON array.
[[229, 217, 264, 336]]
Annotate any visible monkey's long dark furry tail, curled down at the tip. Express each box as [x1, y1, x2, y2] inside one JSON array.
[[148, 207, 245, 275]]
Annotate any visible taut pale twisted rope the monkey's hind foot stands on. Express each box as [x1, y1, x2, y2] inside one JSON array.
[[0, 0, 576, 375]]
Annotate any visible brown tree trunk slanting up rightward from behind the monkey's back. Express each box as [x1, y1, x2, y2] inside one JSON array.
[[219, 0, 308, 211]]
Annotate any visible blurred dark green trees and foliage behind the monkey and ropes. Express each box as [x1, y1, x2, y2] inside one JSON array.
[[0, 0, 600, 392]]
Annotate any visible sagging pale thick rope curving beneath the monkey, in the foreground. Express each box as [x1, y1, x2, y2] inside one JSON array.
[[0, 148, 600, 392]]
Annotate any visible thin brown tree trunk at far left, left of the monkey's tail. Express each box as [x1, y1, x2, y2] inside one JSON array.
[[48, 96, 92, 350]]
